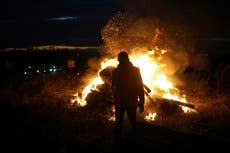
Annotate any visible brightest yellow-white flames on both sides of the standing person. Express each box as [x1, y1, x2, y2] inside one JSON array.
[[72, 48, 193, 120]]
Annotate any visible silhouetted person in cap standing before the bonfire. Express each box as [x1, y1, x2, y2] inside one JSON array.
[[112, 51, 145, 144]]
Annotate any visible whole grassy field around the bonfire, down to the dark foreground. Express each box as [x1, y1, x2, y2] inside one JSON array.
[[0, 59, 230, 152]]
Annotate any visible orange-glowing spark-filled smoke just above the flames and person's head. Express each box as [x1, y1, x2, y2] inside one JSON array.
[[102, 12, 191, 75]]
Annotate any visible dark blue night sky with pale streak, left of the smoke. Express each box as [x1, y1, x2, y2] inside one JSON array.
[[0, 0, 117, 47]]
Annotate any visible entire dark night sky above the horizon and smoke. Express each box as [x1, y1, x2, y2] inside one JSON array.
[[0, 0, 230, 47]]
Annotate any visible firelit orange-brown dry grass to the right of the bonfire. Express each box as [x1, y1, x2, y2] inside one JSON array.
[[150, 65, 230, 135]]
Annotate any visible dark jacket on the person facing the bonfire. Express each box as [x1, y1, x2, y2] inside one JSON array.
[[112, 62, 144, 106]]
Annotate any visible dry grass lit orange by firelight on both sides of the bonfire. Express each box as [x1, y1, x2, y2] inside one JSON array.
[[0, 64, 230, 143]]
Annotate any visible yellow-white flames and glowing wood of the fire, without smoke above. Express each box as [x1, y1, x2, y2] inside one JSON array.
[[72, 47, 194, 120]]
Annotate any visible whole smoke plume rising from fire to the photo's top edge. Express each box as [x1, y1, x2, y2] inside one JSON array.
[[101, 0, 221, 74]]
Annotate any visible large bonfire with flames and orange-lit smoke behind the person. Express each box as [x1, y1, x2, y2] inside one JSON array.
[[71, 13, 194, 120]]
